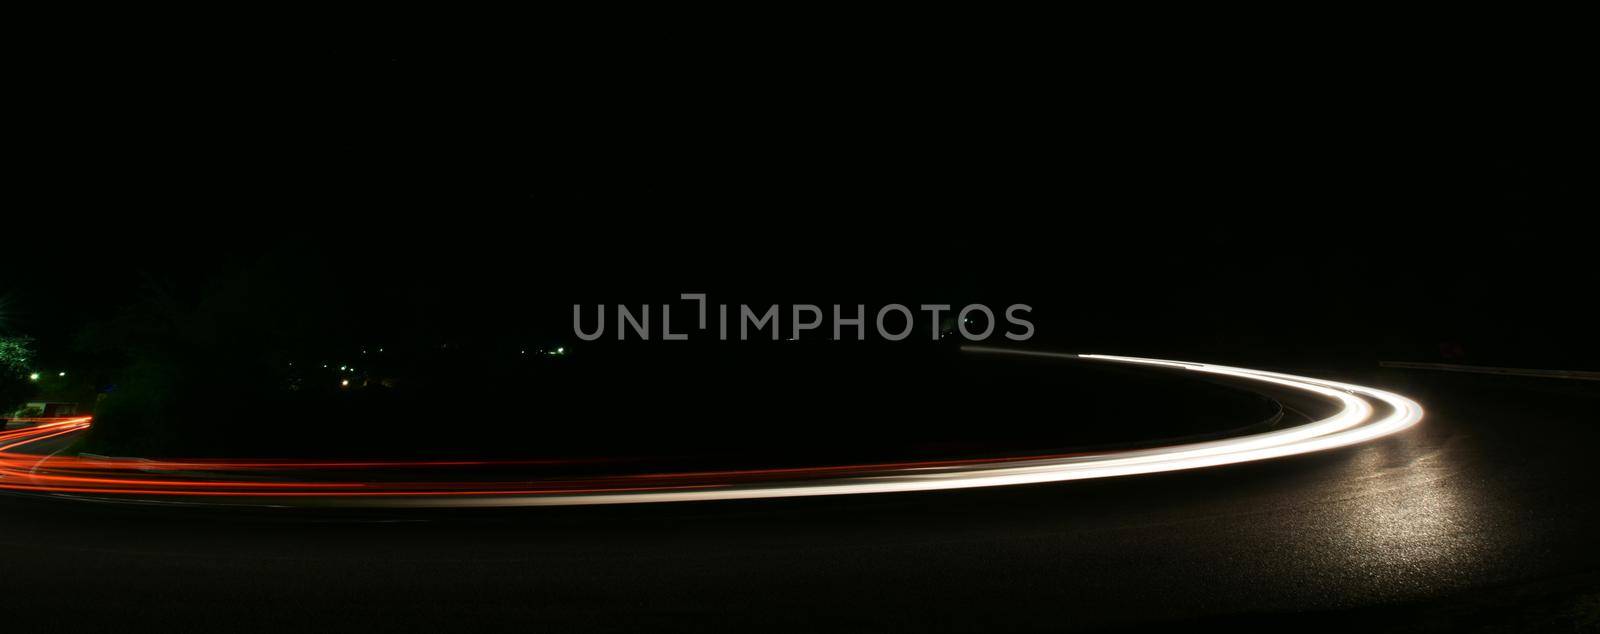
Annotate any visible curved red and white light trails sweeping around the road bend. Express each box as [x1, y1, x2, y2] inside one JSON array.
[[0, 352, 1422, 508]]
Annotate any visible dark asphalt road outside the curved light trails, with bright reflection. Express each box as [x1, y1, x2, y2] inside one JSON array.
[[0, 370, 1600, 632]]
